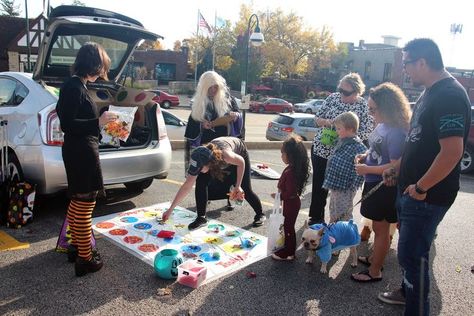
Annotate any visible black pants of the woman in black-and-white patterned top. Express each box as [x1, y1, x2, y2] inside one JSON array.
[[309, 153, 328, 223]]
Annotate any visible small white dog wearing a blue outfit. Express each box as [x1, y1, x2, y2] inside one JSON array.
[[298, 220, 360, 273]]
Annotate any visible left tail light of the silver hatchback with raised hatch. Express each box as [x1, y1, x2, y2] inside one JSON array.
[[38, 104, 64, 146]]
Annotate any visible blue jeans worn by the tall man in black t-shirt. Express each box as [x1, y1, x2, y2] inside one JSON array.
[[398, 194, 450, 316]]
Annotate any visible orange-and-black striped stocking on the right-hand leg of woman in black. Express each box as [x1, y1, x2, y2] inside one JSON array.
[[74, 201, 95, 260]]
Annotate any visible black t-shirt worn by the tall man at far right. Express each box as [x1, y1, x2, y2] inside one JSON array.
[[399, 77, 471, 206]]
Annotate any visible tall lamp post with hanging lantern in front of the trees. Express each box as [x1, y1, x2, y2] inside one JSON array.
[[241, 13, 264, 139]]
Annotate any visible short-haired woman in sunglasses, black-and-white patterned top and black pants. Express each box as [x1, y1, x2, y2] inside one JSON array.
[[309, 73, 374, 225]]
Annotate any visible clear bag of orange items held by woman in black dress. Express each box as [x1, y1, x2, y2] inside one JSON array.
[[101, 105, 137, 146]]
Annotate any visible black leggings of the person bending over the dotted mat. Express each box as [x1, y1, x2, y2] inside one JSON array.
[[194, 154, 263, 216]]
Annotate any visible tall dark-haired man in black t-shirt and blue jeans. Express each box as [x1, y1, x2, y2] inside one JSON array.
[[378, 38, 471, 315]]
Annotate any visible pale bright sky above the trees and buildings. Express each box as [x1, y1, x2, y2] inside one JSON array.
[[20, 0, 474, 69]]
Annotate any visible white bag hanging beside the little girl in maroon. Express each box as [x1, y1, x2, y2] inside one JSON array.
[[267, 193, 285, 254]]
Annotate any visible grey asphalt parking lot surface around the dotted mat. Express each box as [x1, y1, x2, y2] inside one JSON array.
[[0, 150, 474, 315]]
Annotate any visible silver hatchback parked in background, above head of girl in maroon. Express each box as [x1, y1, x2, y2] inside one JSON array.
[[265, 113, 316, 140]]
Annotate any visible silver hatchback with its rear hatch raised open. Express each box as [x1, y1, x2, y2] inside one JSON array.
[[0, 6, 171, 194]]
